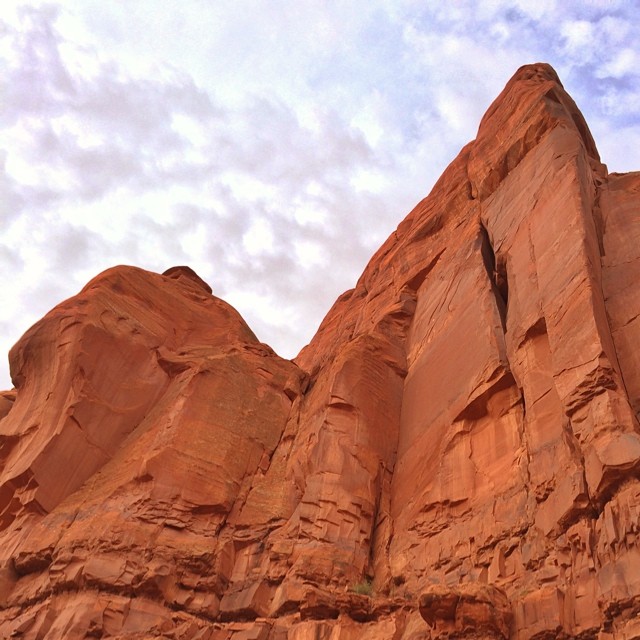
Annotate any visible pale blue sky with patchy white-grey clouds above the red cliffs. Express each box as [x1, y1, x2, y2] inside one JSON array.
[[0, 0, 640, 389]]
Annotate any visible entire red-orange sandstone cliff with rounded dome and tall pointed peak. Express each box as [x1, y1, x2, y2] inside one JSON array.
[[0, 64, 640, 640]]
